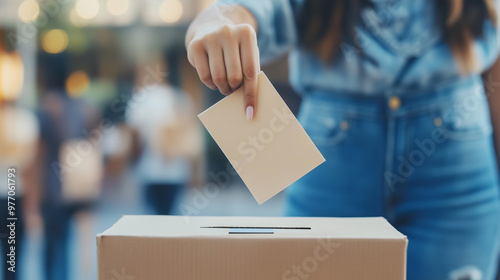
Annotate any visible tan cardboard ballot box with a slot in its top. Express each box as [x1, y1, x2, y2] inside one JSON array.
[[97, 216, 407, 280]]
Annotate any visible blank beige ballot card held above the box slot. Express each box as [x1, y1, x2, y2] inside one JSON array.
[[198, 72, 325, 204]]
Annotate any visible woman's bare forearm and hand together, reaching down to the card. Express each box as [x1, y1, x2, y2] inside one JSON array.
[[185, 5, 260, 120]]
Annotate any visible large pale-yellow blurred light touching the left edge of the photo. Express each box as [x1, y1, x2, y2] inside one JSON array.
[[0, 51, 24, 101]]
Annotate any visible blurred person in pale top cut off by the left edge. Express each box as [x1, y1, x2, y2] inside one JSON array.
[[0, 49, 40, 280]]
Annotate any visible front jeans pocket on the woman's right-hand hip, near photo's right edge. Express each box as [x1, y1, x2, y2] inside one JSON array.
[[436, 100, 493, 141]]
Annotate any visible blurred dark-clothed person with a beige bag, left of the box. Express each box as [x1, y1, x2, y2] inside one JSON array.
[[38, 53, 102, 280]]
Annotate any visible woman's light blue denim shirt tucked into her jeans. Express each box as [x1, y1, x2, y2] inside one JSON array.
[[218, 0, 498, 95]]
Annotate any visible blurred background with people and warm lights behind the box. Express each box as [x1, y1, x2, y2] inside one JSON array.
[[0, 0, 300, 280]]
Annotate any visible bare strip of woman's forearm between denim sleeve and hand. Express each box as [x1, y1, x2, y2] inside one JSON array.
[[185, 5, 258, 48]]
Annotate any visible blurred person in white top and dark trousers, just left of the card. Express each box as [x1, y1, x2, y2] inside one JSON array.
[[126, 56, 201, 215]]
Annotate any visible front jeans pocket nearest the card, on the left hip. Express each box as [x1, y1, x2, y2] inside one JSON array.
[[299, 108, 350, 146]]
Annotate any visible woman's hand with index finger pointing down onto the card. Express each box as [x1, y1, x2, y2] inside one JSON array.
[[187, 24, 260, 120]]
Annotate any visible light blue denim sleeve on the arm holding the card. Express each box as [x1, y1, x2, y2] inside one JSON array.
[[216, 0, 302, 64]]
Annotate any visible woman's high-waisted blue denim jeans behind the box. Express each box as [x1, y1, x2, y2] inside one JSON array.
[[287, 76, 500, 280]]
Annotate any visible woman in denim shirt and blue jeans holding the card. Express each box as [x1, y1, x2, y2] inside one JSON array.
[[186, 0, 500, 280]]
